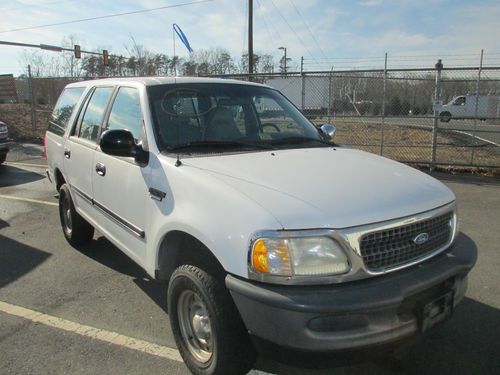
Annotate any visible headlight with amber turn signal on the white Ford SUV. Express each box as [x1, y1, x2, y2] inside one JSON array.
[[249, 237, 350, 277]]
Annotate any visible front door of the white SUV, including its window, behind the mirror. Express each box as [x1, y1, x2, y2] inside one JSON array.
[[92, 86, 150, 265]]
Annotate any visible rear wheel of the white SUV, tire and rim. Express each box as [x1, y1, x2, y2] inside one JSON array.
[[59, 184, 94, 247]]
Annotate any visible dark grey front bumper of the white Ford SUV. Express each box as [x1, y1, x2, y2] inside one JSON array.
[[226, 234, 477, 352]]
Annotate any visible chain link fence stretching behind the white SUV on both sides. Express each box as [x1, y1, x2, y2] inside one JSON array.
[[0, 63, 500, 168]]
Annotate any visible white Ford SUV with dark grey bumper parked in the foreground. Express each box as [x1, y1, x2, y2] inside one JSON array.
[[46, 77, 477, 374]]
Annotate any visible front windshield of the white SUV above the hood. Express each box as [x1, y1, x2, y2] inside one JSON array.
[[148, 83, 329, 153]]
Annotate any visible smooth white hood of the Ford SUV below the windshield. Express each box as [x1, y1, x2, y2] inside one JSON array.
[[183, 147, 455, 229]]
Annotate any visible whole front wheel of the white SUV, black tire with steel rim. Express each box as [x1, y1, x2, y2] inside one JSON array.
[[168, 265, 255, 375]]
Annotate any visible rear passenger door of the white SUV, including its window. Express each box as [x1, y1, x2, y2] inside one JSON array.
[[63, 86, 114, 221]]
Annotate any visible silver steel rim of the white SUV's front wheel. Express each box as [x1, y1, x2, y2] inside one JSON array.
[[177, 290, 213, 363]]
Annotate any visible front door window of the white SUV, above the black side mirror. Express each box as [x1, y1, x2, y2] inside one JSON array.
[[107, 87, 142, 140]]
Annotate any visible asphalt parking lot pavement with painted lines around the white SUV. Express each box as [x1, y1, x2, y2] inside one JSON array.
[[0, 145, 500, 375]]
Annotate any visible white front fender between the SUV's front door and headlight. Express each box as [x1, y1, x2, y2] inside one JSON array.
[[147, 160, 282, 277]]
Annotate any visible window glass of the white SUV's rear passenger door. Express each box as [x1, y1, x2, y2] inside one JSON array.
[[75, 87, 113, 142]]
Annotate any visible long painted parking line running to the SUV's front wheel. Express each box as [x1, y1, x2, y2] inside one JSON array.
[[0, 301, 182, 362]]
